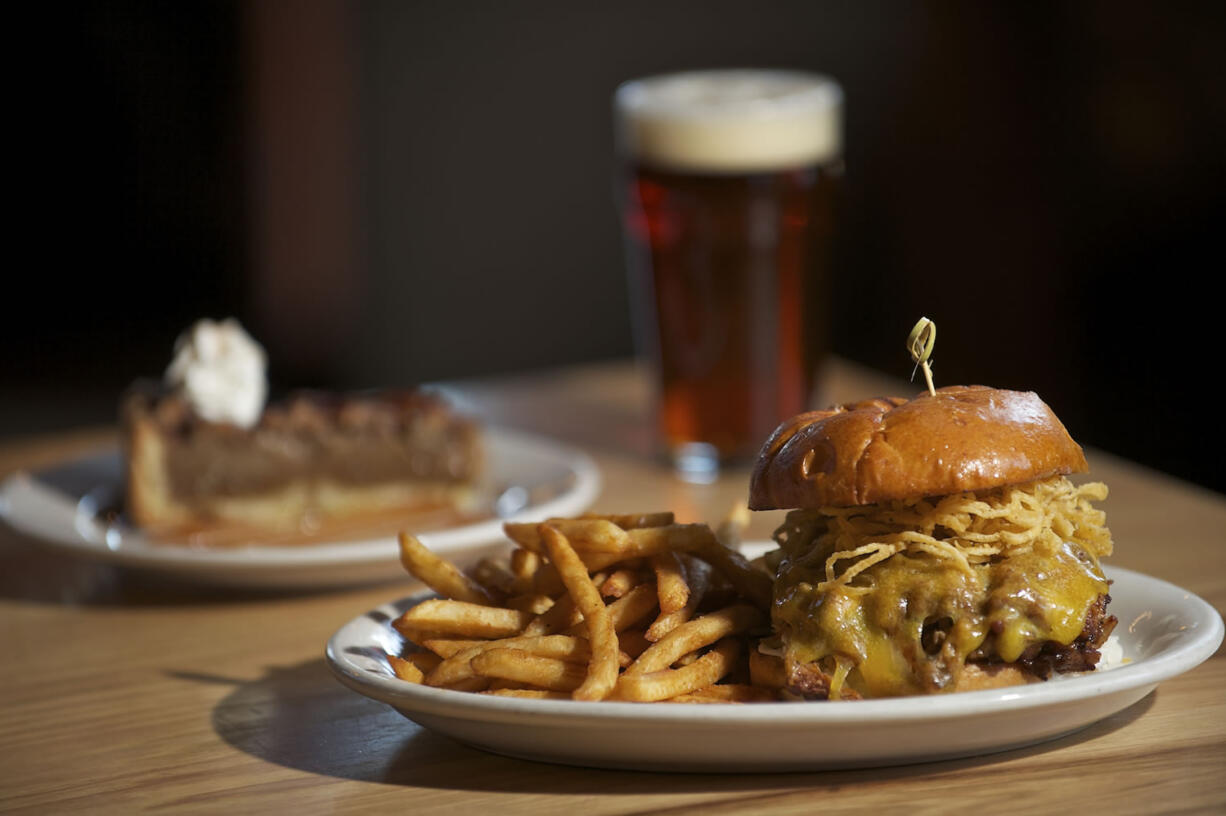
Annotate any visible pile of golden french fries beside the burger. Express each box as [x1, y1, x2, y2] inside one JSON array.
[[389, 512, 783, 702]]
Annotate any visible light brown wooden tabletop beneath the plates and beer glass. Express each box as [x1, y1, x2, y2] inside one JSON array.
[[0, 360, 1226, 815]]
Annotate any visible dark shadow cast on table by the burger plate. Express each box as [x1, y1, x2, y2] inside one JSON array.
[[203, 659, 1156, 794]]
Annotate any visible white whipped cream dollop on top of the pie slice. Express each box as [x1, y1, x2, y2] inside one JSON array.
[[166, 317, 268, 428]]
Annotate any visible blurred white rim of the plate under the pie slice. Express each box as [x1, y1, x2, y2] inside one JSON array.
[[0, 425, 603, 573]]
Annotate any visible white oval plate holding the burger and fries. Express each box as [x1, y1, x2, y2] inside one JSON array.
[[327, 570, 1222, 772]]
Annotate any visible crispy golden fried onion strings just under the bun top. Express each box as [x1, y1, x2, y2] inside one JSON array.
[[776, 477, 1111, 592]]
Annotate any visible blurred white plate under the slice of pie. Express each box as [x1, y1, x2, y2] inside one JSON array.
[[0, 429, 601, 588]]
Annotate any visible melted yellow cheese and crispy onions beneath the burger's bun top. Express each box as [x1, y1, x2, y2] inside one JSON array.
[[772, 478, 1111, 697]]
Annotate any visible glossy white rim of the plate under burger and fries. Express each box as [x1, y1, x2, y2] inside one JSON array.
[[324, 558, 1224, 728]]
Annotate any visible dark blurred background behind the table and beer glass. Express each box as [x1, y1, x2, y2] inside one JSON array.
[[0, 0, 1226, 491]]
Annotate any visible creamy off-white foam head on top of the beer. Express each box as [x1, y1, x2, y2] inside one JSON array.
[[614, 69, 842, 174]]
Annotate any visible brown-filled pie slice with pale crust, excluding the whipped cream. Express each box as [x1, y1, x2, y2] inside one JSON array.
[[123, 388, 482, 533]]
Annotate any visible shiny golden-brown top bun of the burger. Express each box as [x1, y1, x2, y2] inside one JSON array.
[[749, 386, 1089, 510]]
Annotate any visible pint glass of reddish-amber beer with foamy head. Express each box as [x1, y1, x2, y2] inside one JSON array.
[[614, 70, 842, 482]]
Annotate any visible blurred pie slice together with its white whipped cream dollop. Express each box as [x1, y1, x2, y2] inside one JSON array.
[[121, 320, 482, 543]]
